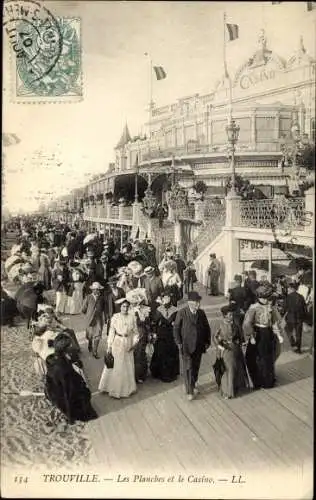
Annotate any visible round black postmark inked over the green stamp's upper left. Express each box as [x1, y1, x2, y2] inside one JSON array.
[[3, 0, 63, 84]]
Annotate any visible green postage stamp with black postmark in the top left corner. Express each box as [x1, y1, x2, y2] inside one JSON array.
[[4, 0, 83, 103]]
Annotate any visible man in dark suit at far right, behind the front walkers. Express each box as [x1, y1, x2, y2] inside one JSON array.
[[285, 282, 307, 354]]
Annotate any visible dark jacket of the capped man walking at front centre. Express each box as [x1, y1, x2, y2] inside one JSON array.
[[173, 306, 211, 354]]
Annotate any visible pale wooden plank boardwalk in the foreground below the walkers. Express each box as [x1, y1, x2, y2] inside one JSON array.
[[84, 353, 313, 474]]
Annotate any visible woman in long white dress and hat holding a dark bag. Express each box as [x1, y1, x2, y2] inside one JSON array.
[[98, 298, 138, 398]]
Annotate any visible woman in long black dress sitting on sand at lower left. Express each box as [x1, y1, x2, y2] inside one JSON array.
[[45, 333, 97, 424]]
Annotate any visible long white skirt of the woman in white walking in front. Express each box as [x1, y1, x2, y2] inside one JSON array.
[[98, 335, 136, 398]]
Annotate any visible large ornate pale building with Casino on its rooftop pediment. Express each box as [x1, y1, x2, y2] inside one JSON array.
[[55, 31, 316, 262]]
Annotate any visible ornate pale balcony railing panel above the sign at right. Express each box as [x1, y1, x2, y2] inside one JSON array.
[[240, 198, 309, 231]]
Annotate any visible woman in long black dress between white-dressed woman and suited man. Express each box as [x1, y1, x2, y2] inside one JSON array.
[[150, 293, 180, 382]]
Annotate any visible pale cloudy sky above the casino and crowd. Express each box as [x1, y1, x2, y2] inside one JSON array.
[[3, 0, 316, 212]]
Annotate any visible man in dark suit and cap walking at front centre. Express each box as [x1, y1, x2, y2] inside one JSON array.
[[173, 291, 211, 401]]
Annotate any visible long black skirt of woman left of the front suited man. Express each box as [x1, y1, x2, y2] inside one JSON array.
[[150, 331, 180, 382]]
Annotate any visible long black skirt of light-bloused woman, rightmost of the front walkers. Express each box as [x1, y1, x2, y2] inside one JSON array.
[[246, 327, 278, 389]]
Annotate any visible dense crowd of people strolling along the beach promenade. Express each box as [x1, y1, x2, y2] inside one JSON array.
[[2, 217, 313, 423]]
